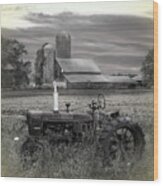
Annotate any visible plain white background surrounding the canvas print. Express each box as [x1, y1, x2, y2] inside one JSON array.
[[0, 0, 163, 186]]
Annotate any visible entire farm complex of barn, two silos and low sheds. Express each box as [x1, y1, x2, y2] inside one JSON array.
[[35, 32, 139, 89]]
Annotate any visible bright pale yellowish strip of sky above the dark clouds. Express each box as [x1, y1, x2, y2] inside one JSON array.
[[1, 0, 153, 28]]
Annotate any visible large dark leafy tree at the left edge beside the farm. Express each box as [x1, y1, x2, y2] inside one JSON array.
[[1, 37, 29, 87]]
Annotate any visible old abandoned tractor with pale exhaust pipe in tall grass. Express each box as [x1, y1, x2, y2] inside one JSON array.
[[22, 82, 145, 169]]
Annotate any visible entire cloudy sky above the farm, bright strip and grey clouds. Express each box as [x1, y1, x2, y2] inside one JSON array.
[[1, 0, 153, 74]]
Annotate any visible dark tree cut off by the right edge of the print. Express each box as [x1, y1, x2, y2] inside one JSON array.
[[141, 49, 154, 87]]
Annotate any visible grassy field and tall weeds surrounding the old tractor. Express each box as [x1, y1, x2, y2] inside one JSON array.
[[1, 92, 154, 180]]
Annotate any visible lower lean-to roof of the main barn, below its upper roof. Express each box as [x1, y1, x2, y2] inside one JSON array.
[[64, 74, 107, 83]]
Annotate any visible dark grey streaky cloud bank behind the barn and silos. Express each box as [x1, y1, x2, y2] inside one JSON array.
[[2, 12, 153, 74]]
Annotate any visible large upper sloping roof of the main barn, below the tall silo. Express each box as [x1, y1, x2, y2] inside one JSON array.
[[57, 58, 101, 74]]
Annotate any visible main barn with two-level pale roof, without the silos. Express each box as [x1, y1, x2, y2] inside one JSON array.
[[55, 58, 107, 89]]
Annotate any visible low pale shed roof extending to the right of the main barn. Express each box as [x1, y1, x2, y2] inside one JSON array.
[[106, 76, 136, 83]]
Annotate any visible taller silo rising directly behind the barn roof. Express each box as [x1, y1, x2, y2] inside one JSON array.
[[56, 32, 71, 58]]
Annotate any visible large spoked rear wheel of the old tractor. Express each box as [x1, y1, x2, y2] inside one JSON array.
[[100, 123, 145, 168]]
